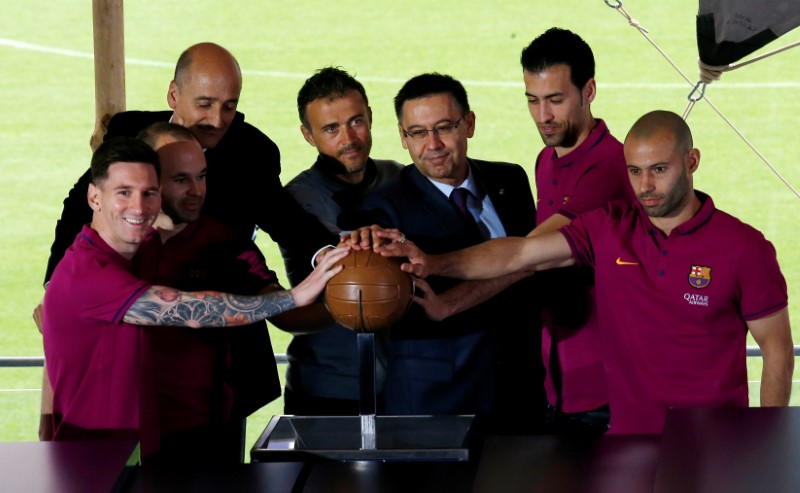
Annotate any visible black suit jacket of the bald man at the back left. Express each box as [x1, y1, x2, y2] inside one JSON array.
[[45, 111, 338, 282]]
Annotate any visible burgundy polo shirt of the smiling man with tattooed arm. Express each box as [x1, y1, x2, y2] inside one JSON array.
[[42, 226, 158, 455]]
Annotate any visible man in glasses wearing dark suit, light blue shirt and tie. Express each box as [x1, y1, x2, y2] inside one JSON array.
[[366, 73, 544, 433]]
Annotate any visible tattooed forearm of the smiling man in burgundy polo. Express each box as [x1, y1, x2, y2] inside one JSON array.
[[124, 286, 295, 328]]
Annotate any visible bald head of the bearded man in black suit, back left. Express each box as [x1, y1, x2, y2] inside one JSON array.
[[167, 43, 242, 149]]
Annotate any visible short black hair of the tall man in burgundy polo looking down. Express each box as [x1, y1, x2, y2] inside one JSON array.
[[520, 27, 594, 89]]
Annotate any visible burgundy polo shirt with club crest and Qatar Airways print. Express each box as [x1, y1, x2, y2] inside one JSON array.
[[561, 192, 788, 433]]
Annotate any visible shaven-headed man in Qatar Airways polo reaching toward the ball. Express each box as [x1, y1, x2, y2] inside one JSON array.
[[378, 111, 794, 433]]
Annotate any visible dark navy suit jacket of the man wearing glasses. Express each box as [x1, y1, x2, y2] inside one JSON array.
[[366, 160, 544, 426]]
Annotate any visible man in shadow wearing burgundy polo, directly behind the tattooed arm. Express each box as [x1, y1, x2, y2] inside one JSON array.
[[137, 122, 290, 465]]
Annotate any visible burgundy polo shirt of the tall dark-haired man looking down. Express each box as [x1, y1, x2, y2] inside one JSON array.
[[536, 119, 633, 413]]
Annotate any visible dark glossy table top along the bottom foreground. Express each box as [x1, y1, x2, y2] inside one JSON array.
[[7, 408, 800, 493]]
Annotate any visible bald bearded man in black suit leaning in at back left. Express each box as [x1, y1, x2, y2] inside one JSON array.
[[45, 43, 338, 283]]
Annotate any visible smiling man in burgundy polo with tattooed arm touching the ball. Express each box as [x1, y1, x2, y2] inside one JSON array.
[[42, 137, 345, 458]]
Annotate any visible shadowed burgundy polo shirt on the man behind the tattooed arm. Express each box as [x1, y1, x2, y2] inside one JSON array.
[[137, 216, 278, 434]]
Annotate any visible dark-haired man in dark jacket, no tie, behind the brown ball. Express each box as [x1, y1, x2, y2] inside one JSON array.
[[281, 67, 402, 416]]
